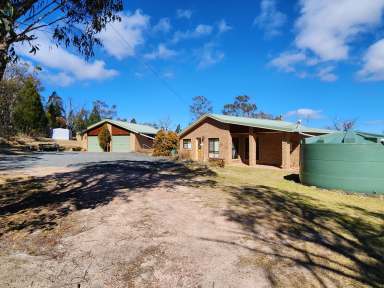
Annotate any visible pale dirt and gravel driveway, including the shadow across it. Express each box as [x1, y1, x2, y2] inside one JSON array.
[[0, 154, 270, 287]]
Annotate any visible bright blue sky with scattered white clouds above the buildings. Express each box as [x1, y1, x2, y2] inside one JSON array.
[[19, 0, 384, 132]]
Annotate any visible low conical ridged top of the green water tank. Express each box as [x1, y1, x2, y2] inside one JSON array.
[[304, 131, 384, 144]]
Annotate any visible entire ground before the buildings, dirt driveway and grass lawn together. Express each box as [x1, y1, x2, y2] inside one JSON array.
[[0, 153, 384, 288]]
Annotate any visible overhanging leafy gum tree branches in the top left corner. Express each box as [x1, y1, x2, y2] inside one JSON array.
[[0, 0, 123, 79]]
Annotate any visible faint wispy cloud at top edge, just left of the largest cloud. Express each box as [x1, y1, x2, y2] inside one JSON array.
[[254, 0, 287, 37]]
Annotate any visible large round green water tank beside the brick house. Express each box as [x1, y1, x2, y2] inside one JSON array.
[[300, 131, 384, 194]]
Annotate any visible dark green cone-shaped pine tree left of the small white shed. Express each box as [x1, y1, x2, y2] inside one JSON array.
[[13, 78, 48, 135]]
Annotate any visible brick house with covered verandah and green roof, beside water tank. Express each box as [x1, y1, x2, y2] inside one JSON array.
[[179, 114, 333, 169]]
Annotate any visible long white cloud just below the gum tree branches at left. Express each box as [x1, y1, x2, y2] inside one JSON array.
[[15, 32, 118, 85]]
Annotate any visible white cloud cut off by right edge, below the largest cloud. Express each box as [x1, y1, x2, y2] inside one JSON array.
[[357, 39, 384, 81]]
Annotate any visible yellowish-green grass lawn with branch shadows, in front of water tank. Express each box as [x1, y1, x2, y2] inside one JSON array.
[[207, 167, 384, 287]]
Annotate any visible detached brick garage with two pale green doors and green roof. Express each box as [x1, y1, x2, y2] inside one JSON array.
[[82, 119, 158, 152]]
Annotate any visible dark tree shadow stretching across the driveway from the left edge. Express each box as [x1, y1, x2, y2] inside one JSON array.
[[0, 161, 215, 236]]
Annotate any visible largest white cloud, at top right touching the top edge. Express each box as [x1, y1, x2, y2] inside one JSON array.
[[295, 0, 384, 61]]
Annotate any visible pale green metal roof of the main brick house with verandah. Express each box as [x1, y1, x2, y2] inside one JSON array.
[[180, 114, 335, 135]]
